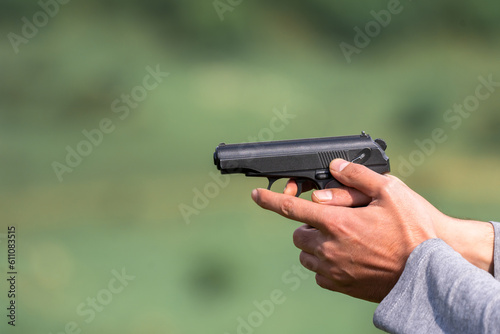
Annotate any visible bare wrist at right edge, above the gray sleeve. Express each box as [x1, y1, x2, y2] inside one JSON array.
[[436, 216, 495, 274]]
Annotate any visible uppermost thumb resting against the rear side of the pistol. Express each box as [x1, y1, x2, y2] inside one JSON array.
[[330, 159, 389, 198]]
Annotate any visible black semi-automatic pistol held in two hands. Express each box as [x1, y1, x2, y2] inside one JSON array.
[[214, 131, 390, 197]]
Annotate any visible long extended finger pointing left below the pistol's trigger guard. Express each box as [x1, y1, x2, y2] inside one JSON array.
[[252, 189, 344, 230]]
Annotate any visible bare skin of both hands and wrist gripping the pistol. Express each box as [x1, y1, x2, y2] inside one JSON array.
[[252, 159, 494, 302]]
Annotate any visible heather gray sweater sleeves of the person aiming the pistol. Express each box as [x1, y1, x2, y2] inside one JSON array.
[[373, 231, 500, 333]]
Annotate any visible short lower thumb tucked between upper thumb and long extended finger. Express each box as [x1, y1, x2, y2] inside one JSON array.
[[311, 187, 372, 207]]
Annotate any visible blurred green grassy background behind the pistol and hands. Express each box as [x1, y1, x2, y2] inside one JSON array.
[[0, 0, 500, 334]]
